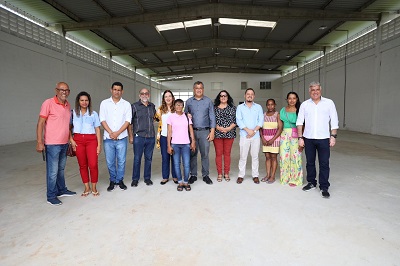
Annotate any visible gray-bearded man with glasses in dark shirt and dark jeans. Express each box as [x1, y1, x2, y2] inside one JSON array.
[[128, 88, 156, 187]]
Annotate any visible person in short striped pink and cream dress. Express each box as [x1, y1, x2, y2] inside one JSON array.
[[260, 99, 282, 184]]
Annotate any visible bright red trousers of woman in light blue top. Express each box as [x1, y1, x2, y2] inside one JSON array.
[[74, 133, 99, 183]]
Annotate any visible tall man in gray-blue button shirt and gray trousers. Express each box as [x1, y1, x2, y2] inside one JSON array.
[[185, 81, 215, 185]]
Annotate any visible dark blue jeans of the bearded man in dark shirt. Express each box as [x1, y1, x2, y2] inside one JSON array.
[[132, 136, 156, 181]]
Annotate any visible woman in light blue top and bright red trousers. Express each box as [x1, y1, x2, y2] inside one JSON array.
[[70, 91, 101, 197]]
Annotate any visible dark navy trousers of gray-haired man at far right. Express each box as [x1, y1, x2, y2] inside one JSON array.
[[304, 138, 331, 190]]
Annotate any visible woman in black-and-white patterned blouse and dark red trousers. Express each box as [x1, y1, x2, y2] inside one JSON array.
[[214, 90, 236, 182]]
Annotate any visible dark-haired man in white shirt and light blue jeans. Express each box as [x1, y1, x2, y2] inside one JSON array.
[[100, 82, 132, 192]]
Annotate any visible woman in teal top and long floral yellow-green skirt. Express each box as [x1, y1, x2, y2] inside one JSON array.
[[279, 92, 303, 187]]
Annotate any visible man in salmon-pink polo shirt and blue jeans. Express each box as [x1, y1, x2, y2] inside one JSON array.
[[36, 82, 76, 205]]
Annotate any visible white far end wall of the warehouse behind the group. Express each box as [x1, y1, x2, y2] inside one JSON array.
[[162, 72, 282, 109]]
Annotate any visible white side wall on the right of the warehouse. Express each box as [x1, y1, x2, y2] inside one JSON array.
[[282, 28, 400, 137]]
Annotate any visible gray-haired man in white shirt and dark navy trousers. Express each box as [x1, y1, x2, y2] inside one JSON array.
[[296, 81, 339, 198]]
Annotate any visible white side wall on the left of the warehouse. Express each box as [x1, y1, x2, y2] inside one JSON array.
[[0, 31, 161, 145]]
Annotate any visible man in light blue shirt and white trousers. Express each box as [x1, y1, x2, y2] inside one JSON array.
[[236, 88, 264, 184]]
